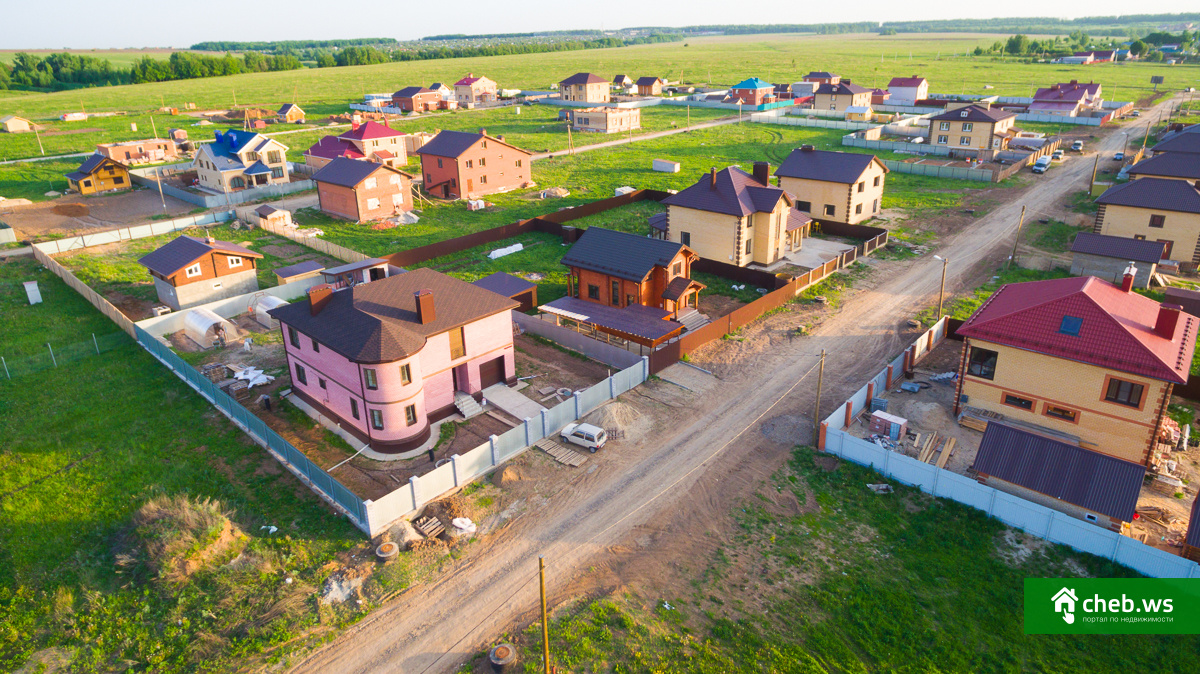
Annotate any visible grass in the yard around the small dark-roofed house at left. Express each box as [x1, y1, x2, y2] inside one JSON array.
[[55, 224, 332, 301]]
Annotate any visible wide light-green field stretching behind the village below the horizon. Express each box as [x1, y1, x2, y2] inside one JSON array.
[[4, 34, 1200, 119]]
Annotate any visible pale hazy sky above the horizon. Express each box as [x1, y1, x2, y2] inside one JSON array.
[[0, 0, 1194, 50]]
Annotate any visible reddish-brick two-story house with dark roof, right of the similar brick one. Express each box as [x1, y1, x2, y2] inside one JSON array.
[[416, 131, 532, 199]]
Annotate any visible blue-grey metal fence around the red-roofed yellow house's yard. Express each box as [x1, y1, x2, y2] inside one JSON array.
[[821, 318, 1200, 578]]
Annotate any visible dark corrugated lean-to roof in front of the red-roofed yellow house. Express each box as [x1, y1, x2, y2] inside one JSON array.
[[972, 421, 1146, 522]]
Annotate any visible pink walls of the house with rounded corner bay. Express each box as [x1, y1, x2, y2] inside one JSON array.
[[280, 312, 516, 444]]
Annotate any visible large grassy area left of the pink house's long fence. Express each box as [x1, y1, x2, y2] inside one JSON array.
[[0, 253, 361, 672]]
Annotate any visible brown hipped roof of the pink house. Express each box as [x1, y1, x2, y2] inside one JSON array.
[[269, 269, 518, 363]]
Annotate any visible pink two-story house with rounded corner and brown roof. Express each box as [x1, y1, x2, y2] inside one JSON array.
[[270, 269, 517, 453]]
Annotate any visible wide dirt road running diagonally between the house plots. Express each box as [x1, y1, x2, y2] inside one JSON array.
[[294, 95, 1180, 674]]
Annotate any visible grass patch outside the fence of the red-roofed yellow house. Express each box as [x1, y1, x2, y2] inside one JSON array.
[[508, 447, 1200, 674]]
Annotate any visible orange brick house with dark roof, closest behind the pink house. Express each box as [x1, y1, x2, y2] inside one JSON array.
[[312, 157, 413, 222]]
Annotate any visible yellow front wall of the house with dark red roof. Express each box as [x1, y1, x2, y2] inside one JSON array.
[[962, 339, 1169, 464]]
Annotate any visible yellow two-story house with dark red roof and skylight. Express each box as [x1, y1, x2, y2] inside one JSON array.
[[955, 269, 1200, 465]]
